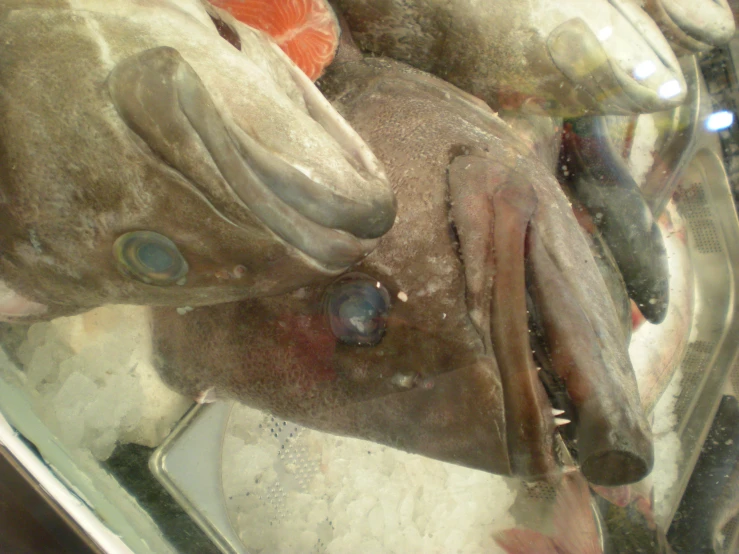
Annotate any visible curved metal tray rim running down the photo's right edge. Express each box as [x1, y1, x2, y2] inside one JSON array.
[[660, 77, 739, 527]]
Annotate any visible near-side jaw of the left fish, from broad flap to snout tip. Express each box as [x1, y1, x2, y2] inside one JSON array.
[[108, 47, 395, 270]]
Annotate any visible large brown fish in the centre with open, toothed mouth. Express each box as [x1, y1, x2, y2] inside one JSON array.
[[153, 34, 653, 484]]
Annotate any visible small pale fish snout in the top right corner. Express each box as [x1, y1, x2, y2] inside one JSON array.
[[644, 0, 736, 56]]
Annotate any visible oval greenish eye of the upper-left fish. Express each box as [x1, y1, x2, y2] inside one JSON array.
[[113, 231, 189, 285]]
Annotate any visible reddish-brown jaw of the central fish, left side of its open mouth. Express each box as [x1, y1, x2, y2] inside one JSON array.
[[449, 155, 557, 478]]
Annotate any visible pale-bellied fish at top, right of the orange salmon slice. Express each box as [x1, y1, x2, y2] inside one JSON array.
[[333, 0, 687, 117]]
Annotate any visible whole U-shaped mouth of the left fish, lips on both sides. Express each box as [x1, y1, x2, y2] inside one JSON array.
[[108, 47, 396, 272]]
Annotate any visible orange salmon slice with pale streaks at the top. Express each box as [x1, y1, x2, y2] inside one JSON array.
[[210, 0, 339, 81]]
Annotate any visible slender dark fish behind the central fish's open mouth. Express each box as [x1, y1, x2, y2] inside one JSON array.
[[561, 117, 670, 324]]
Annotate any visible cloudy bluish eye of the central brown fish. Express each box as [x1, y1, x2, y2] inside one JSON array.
[[324, 273, 390, 346]]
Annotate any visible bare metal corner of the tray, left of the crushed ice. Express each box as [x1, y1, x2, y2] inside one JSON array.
[[149, 401, 247, 554]]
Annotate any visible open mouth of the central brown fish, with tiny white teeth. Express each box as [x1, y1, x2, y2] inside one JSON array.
[[449, 154, 653, 485]]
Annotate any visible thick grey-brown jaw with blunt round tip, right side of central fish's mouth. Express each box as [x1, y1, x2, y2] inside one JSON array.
[[527, 167, 654, 485]]
